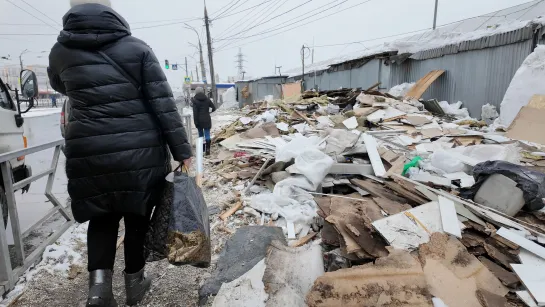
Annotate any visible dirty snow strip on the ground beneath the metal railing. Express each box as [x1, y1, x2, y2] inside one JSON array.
[[0, 223, 89, 307]]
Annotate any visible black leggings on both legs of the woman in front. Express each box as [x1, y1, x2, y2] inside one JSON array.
[[87, 214, 149, 274]]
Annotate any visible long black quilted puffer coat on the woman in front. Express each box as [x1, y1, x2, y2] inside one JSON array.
[[49, 4, 191, 222]]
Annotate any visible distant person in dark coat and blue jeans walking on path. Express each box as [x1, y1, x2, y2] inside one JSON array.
[[191, 87, 216, 156]]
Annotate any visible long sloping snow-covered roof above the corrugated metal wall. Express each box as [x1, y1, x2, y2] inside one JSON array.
[[280, 0, 545, 77]]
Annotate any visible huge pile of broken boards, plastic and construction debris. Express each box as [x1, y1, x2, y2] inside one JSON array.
[[200, 75, 545, 306]]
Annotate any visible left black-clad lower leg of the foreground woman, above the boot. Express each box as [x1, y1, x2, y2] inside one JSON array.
[[87, 214, 121, 272]]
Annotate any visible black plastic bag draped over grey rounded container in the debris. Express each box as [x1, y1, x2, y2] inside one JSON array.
[[460, 161, 545, 211]]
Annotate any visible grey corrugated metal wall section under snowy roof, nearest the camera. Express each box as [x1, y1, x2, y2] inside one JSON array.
[[390, 40, 532, 118]]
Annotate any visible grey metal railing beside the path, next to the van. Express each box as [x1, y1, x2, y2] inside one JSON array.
[[0, 140, 74, 295]]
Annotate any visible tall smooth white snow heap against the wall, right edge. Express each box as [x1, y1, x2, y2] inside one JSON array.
[[495, 45, 545, 127]]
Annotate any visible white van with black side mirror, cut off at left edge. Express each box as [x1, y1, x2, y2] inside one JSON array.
[[0, 70, 38, 226]]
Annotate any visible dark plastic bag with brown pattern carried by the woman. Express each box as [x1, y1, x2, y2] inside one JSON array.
[[144, 172, 212, 267]]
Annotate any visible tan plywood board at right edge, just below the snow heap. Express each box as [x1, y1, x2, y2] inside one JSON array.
[[505, 107, 545, 145]]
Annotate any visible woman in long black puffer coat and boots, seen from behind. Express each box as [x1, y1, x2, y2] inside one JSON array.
[[48, 0, 192, 306]]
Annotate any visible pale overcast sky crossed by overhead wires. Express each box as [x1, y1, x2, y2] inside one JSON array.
[[0, 0, 528, 88]]
